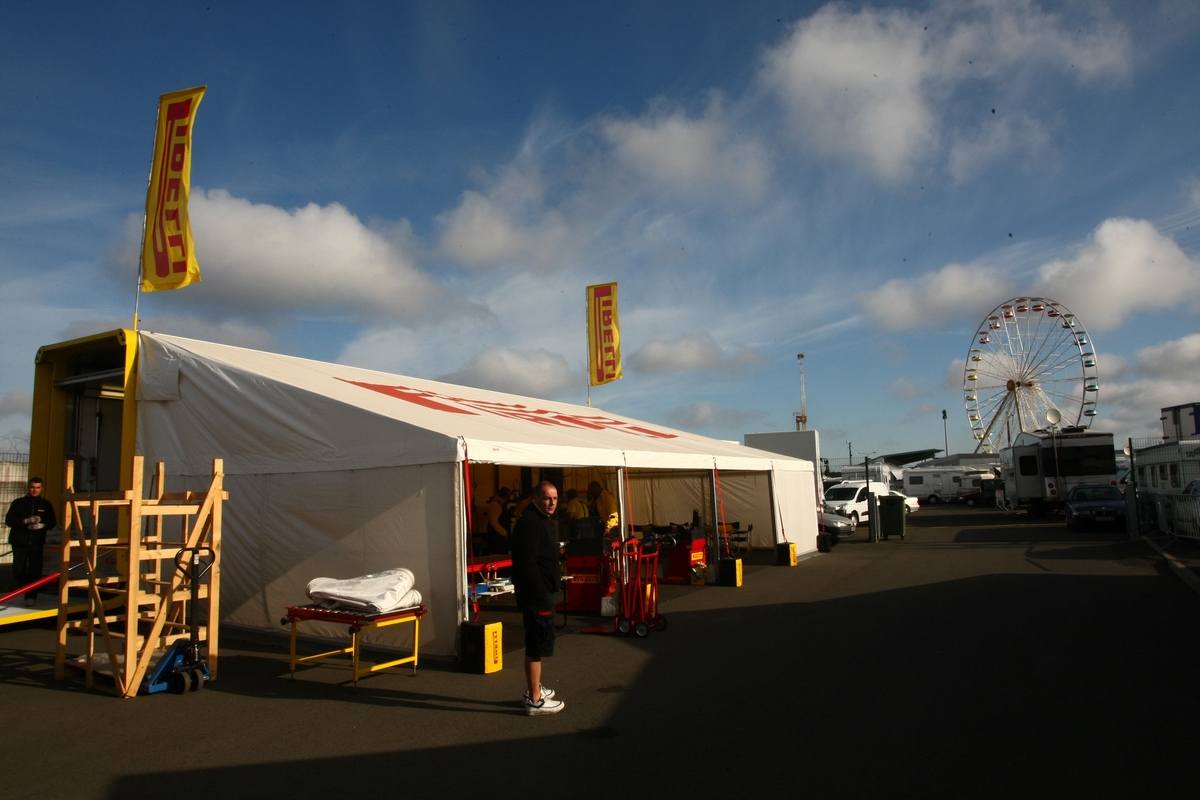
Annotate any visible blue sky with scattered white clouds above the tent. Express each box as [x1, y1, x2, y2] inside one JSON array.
[[0, 0, 1200, 457]]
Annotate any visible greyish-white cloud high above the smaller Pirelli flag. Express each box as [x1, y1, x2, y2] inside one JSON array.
[[601, 96, 770, 200]]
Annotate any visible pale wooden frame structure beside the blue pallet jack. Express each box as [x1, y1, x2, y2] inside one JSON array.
[[54, 456, 229, 697]]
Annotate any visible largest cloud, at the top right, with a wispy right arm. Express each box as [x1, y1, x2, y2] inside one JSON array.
[[762, 0, 1133, 181]]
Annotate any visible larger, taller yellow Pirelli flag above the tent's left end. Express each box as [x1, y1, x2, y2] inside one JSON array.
[[142, 86, 208, 291]]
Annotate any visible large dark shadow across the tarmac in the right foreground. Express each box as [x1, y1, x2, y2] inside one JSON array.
[[98, 563, 1200, 800]]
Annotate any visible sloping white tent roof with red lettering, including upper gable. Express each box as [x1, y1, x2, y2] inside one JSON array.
[[138, 332, 812, 471]]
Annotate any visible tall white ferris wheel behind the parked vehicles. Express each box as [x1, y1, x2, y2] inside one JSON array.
[[962, 297, 1099, 453]]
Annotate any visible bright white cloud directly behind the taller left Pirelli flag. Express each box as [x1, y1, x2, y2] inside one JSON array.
[[109, 190, 439, 318]]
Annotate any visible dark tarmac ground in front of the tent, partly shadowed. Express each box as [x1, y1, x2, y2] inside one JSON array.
[[0, 506, 1200, 800]]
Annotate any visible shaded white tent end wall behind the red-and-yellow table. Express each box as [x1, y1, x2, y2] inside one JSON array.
[[169, 462, 461, 655]]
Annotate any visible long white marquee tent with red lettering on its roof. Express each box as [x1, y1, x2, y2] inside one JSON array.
[[137, 332, 817, 654]]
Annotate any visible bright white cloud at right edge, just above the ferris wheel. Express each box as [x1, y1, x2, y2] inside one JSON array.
[[1033, 218, 1200, 330]]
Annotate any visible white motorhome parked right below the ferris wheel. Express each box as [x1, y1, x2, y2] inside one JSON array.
[[1000, 428, 1117, 511]]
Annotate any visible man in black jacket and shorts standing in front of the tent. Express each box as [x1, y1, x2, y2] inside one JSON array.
[[512, 481, 566, 716]]
